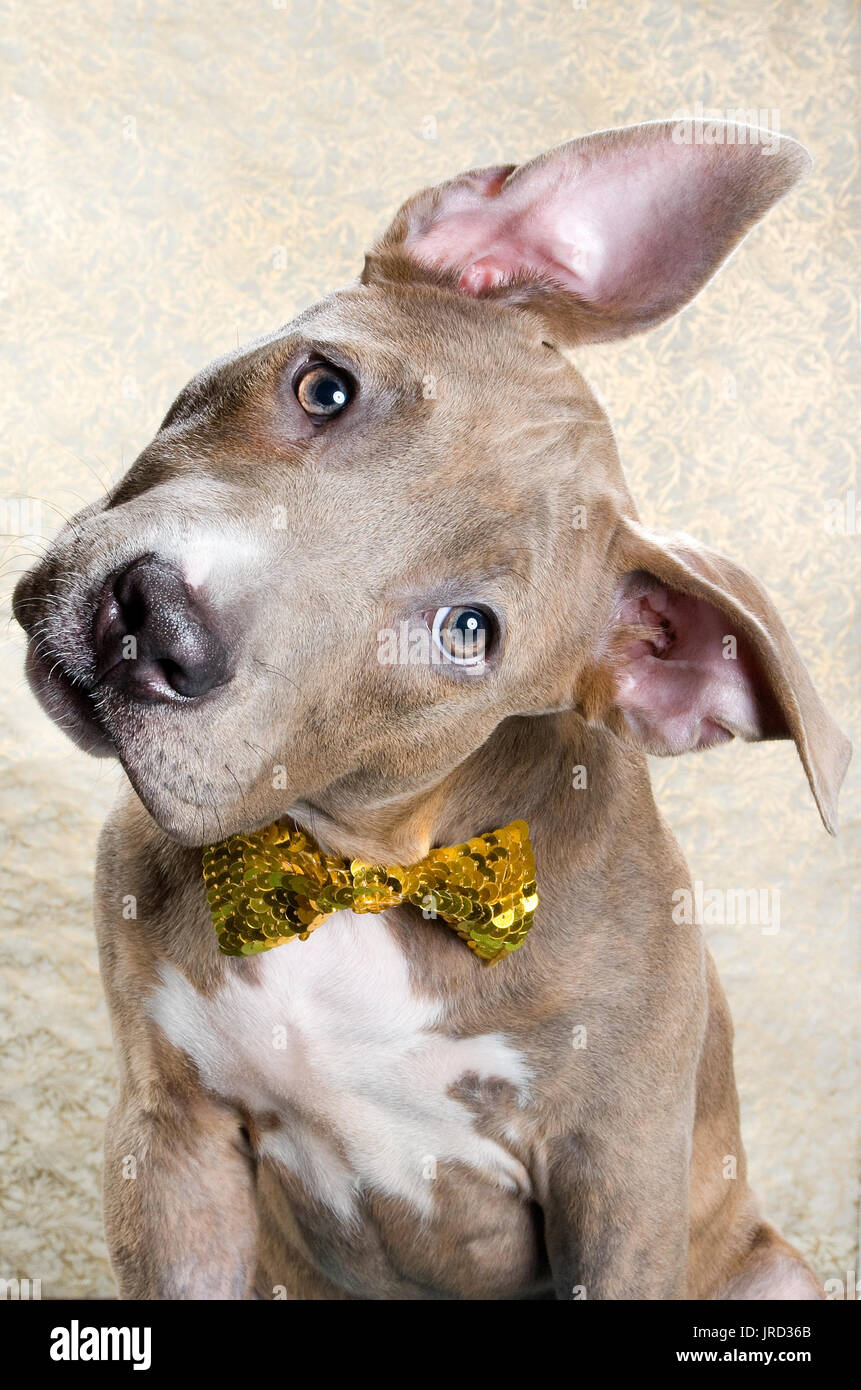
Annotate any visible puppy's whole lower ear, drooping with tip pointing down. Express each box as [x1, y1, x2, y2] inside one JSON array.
[[579, 518, 851, 834]]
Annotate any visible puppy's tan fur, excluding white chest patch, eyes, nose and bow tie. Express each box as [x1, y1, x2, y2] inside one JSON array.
[[11, 122, 847, 1300]]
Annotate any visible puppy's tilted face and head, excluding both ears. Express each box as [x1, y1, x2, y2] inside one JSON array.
[[17, 285, 625, 840]]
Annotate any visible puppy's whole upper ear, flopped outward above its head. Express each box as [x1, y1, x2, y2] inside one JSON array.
[[362, 121, 811, 346]]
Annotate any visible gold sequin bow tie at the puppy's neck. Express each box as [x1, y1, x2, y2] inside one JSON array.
[[203, 820, 538, 965]]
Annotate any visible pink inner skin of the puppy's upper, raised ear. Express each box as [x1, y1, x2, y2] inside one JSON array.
[[406, 136, 725, 313]]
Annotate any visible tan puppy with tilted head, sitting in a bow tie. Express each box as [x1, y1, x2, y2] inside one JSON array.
[[14, 122, 850, 1300]]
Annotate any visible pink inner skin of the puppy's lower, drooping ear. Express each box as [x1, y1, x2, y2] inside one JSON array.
[[616, 588, 771, 753]]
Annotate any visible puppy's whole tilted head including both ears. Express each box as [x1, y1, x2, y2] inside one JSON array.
[[15, 125, 843, 844]]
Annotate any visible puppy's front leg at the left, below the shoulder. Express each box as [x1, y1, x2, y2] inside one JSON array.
[[104, 1093, 257, 1300]]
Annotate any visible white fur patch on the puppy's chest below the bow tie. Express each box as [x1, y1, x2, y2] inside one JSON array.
[[149, 912, 530, 1219]]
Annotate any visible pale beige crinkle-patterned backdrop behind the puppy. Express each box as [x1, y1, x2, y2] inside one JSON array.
[[0, 0, 861, 1295]]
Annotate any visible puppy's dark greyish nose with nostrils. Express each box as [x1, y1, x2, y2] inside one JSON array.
[[93, 555, 232, 701]]
